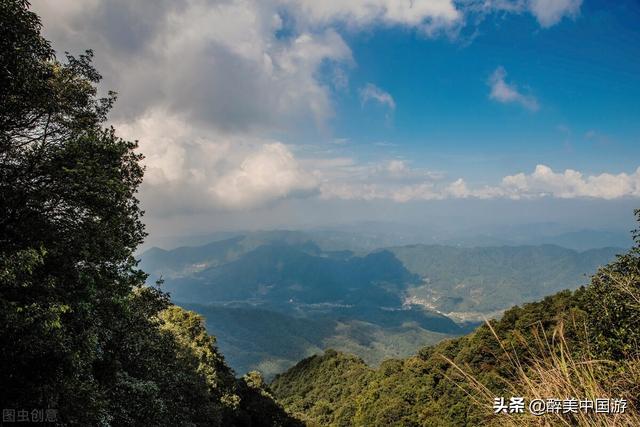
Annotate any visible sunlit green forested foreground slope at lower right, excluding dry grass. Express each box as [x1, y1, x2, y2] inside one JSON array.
[[271, 289, 640, 426]]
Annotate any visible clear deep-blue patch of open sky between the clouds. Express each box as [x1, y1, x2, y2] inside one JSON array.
[[302, 2, 640, 182]]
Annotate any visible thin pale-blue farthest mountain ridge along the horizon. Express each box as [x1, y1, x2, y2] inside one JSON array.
[[141, 226, 633, 253]]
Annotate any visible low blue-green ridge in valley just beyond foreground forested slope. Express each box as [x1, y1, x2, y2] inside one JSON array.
[[183, 304, 449, 378]]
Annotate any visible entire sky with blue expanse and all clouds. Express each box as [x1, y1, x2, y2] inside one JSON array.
[[33, 0, 640, 234]]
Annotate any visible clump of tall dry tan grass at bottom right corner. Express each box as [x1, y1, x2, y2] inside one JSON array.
[[443, 322, 640, 427]]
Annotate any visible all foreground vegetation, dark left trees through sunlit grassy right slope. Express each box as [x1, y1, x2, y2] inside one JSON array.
[[0, 0, 640, 426]]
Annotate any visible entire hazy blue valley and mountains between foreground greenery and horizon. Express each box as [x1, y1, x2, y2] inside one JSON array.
[[141, 227, 624, 376]]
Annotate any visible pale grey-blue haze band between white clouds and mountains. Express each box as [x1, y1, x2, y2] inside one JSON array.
[[141, 200, 636, 251]]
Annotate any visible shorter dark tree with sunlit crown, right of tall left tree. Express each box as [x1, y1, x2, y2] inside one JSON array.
[[94, 288, 222, 425]]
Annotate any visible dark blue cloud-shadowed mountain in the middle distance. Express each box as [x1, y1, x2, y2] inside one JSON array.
[[162, 245, 417, 306]]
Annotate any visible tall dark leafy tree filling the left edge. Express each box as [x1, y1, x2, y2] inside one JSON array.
[[0, 0, 145, 423]]
